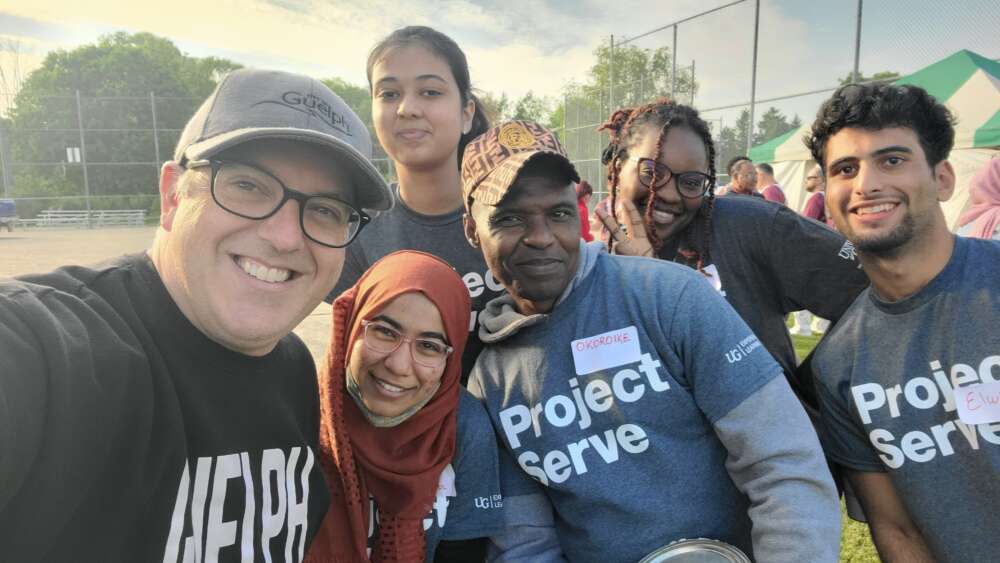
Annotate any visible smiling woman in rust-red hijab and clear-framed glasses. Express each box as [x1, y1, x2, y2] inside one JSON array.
[[306, 251, 502, 563]]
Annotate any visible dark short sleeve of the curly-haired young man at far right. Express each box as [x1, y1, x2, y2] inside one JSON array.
[[816, 358, 885, 472]]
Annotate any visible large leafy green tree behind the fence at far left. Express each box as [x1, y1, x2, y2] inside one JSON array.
[[4, 32, 239, 207]]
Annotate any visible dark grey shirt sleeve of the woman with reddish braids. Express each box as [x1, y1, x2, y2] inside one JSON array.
[[767, 208, 868, 322]]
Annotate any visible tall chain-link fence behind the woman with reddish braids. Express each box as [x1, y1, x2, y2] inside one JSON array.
[[557, 0, 1000, 203]]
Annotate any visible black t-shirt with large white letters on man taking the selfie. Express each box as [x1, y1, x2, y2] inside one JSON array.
[[0, 255, 329, 562]]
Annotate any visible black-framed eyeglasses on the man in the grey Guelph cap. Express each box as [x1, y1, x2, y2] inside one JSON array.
[[187, 160, 371, 248]]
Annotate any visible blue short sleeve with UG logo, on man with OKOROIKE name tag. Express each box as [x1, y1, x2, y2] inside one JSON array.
[[660, 269, 782, 423]]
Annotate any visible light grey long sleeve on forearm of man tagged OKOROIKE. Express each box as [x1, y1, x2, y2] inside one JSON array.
[[715, 377, 840, 562]]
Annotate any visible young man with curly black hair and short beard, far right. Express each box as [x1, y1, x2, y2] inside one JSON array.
[[808, 84, 1000, 563]]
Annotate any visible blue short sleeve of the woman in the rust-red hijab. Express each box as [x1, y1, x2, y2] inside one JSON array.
[[441, 391, 503, 540]]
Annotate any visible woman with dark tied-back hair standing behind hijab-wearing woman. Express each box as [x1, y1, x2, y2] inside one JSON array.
[[327, 26, 503, 388]]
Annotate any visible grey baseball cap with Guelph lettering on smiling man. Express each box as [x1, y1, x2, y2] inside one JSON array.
[[174, 68, 393, 211]]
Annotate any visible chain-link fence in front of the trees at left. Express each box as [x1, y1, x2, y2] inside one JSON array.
[[0, 92, 392, 220]]
